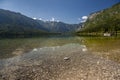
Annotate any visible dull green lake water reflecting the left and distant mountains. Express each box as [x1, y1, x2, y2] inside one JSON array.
[[0, 36, 82, 58]]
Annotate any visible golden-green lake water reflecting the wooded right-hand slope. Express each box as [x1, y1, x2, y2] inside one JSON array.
[[84, 37, 120, 63]]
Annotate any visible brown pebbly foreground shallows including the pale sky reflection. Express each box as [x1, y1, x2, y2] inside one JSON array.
[[0, 44, 120, 80]]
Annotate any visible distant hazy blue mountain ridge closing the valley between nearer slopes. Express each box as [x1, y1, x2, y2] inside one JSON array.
[[36, 20, 81, 33]]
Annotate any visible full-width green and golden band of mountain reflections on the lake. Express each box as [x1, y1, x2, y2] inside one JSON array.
[[0, 36, 120, 62]]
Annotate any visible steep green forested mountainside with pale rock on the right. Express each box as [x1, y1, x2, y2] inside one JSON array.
[[79, 3, 120, 34]]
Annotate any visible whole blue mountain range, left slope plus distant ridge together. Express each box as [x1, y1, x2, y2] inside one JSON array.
[[0, 9, 81, 36]]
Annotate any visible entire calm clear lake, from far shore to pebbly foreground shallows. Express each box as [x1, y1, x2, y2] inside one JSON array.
[[0, 35, 120, 80]]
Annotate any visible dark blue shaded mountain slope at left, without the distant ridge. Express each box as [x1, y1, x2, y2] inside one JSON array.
[[0, 9, 47, 35]]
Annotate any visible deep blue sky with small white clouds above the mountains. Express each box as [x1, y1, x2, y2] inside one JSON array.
[[0, 0, 120, 24]]
